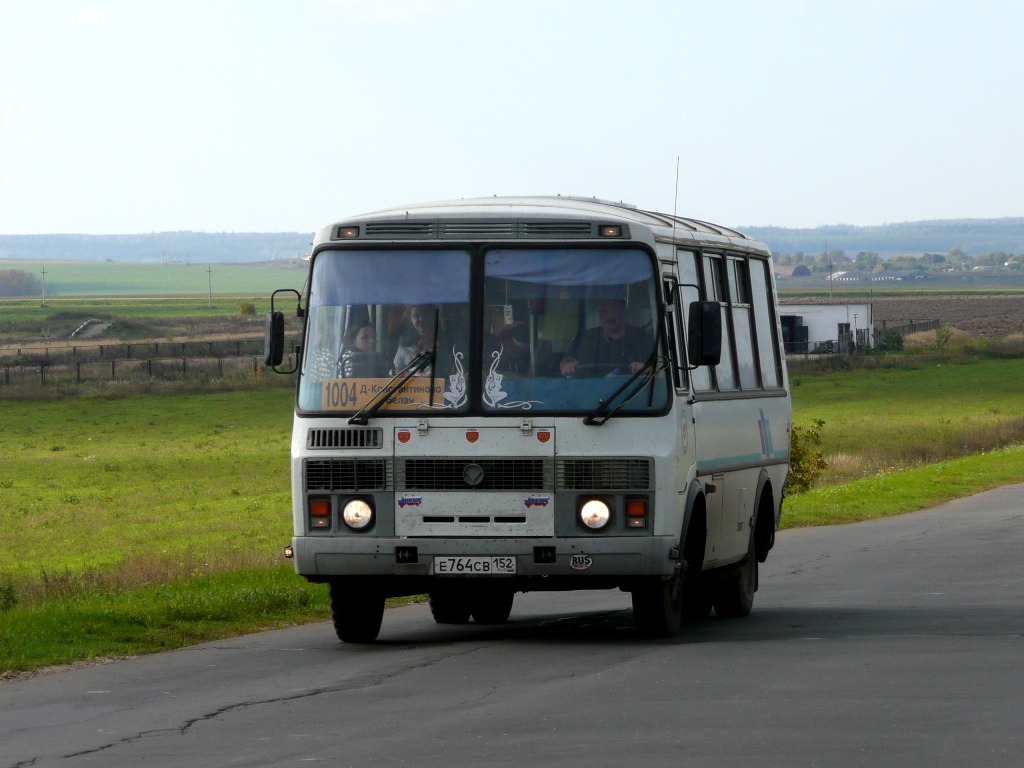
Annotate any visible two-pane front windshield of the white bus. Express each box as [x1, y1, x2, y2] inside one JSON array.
[[299, 248, 669, 416]]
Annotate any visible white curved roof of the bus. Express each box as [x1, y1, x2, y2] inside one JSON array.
[[316, 196, 768, 252]]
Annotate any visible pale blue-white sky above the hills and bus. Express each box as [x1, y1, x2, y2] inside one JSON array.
[[0, 0, 1024, 234]]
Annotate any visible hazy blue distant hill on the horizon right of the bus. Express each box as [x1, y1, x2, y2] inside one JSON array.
[[736, 217, 1024, 257]]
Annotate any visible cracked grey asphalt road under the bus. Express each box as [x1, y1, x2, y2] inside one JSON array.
[[0, 485, 1024, 768]]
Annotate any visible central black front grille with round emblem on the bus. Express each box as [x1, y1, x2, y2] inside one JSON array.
[[396, 459, 552, 490]]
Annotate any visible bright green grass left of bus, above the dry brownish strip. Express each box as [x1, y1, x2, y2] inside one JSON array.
[[0, 388, 292, 584]]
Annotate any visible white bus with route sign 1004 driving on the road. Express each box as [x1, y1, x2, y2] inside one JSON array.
[[266, 197, 791, 642]]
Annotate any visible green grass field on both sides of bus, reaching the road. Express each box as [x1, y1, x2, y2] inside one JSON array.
[[0, 357, 1024, 674]]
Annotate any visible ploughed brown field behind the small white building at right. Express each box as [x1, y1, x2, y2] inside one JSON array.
[[779, 294, 1024, 339]]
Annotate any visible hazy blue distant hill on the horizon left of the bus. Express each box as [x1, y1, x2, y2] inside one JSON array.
[[0, 232, 313, 264]]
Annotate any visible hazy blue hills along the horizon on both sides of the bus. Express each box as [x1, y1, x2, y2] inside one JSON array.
[[0, 217, 1024, 264]]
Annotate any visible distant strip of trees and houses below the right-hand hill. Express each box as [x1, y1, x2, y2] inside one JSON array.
[[774, 248, 1024, 274]]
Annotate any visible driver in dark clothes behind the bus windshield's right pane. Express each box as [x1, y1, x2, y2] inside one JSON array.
[[558, 299, 652, 376]]
